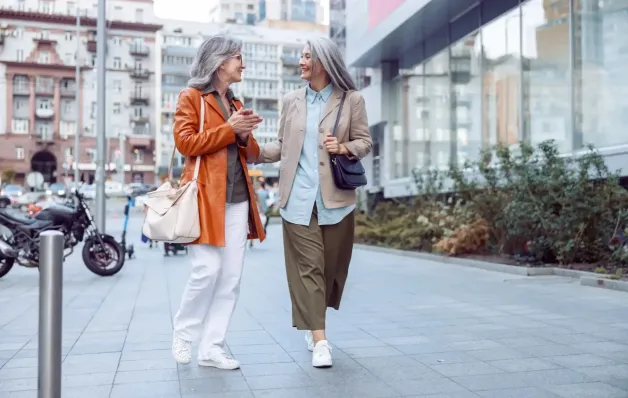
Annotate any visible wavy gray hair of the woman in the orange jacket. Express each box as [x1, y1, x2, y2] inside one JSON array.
[[188, 35, 242, 91]]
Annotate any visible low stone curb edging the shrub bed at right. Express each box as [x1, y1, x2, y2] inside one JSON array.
[[353, 243, 628, 292]]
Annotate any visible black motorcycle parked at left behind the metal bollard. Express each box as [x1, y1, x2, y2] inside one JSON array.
[[0, 190, 125, 278]]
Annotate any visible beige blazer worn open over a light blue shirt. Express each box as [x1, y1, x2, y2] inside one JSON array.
[[255, 87, 372, 209]]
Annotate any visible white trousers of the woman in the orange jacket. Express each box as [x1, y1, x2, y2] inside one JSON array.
[[173, 201, 249, 359]]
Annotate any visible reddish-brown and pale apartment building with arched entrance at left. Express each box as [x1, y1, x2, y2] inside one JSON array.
[[0, 0, 161, 183]]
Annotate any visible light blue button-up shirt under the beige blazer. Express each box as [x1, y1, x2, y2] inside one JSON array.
[[279, 84, 355, 225]]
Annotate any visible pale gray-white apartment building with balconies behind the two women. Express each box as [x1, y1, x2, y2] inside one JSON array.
[[156, 20, 323, 177]]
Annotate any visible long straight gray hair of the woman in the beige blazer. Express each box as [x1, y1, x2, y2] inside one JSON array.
[[307, 37, 356, 91]]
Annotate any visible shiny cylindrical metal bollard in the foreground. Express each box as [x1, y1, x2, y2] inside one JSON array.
[[37, 231, 63, 398]]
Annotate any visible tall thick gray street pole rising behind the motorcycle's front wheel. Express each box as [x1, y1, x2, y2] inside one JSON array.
[[96, 0, 107, 233]]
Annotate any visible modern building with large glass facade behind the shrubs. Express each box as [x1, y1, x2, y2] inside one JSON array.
[[347, 0, 628, 196]]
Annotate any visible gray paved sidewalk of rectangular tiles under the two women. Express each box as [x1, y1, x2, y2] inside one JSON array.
[[0, 220, 628, 398]]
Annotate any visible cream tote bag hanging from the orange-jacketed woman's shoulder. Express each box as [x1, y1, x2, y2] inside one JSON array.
[[142, 96, 205, 243]]
